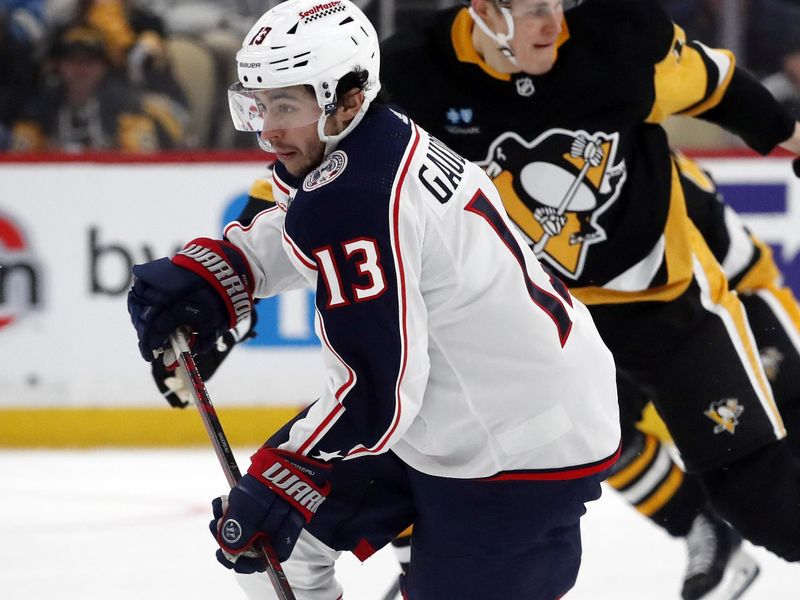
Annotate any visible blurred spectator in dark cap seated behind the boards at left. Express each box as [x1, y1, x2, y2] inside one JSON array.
[[11, 25, 169, 152]]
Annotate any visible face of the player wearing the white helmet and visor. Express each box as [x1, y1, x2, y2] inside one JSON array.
[[255, 85, 325, 177]]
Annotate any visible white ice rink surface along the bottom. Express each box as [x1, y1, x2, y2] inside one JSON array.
[[0, 448, 800, 600]]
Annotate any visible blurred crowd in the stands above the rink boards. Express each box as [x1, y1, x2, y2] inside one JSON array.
[[0, 0, 800, 152]]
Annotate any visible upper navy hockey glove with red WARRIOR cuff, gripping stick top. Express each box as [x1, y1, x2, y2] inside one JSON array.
[[128, 238, 253, 362]]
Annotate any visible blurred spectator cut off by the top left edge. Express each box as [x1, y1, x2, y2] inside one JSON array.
[[0, 0, 45, 150]]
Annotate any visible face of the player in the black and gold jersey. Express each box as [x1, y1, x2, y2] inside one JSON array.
[[510, 0, 564, 75]]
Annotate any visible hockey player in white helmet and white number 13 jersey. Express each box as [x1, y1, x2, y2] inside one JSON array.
[[128, 0, 620, 600]]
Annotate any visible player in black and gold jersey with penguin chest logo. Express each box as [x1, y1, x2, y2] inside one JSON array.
[[383, 0, 800, 592]]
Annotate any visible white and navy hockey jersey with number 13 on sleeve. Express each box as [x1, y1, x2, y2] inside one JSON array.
[[225, 106, 620, 479]]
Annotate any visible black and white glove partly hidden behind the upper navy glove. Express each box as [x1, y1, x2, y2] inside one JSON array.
[[151, 310, 258, 408]]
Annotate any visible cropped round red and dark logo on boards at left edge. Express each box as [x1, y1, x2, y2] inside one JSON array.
[[0, 213, 41, 329]]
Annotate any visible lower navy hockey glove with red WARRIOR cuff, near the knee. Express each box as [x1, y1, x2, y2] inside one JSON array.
[[210, 447, 331, 573]]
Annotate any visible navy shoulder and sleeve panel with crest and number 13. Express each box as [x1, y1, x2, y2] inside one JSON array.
[[285, 105, 417, 456]]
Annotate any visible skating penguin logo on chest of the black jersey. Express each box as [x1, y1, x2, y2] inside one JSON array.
[[484, 129, 626, 279]]
